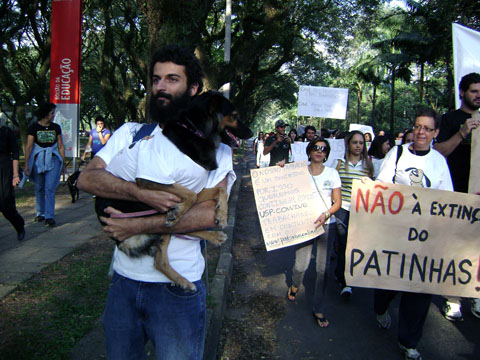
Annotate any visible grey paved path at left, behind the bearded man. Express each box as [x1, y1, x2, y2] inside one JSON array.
[[0, 190, 101, 298]]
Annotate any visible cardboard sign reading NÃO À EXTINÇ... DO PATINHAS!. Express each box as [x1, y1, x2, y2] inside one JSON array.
[[345, 180, 480, 298]]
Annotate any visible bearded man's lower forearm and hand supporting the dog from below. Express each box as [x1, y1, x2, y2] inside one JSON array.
[[100, 178, 227, 241]]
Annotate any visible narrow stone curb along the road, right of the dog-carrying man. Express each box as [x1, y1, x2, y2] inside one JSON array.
[[203, 150, 246, 360]]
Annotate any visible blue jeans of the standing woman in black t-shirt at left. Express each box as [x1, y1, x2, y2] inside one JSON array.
[[33, 156, 62, 219]]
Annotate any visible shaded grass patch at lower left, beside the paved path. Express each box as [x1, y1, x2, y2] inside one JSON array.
[[0, 234, 112, 360]]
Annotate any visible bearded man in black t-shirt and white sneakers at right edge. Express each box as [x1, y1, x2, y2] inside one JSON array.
[[434, 73, 480, 321]]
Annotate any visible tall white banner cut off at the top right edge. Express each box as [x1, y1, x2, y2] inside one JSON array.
[[452, 24, 480, 109]]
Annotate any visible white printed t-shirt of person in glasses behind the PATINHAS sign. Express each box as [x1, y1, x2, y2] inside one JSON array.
[[377, 144, 453, 191]]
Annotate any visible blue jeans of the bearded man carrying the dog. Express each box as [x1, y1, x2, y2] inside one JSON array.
[[103, 273, 206, 360]]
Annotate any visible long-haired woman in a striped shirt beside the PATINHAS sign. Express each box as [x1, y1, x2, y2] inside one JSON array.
[[335, 130, 373, 298]]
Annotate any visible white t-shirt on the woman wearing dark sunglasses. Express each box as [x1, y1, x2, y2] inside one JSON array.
[[310, 166, 342, 224]]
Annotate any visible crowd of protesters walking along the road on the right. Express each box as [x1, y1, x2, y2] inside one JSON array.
[[254, 73, 480, 360]]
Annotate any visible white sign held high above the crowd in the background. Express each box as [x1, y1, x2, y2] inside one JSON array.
[[297, 85, 348, 119]]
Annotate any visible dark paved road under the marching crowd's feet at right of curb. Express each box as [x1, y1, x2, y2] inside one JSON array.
[[218, 143, 480, 360]]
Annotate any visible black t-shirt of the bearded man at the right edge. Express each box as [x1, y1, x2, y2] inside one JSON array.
[[437, 109, 472, 193]]
